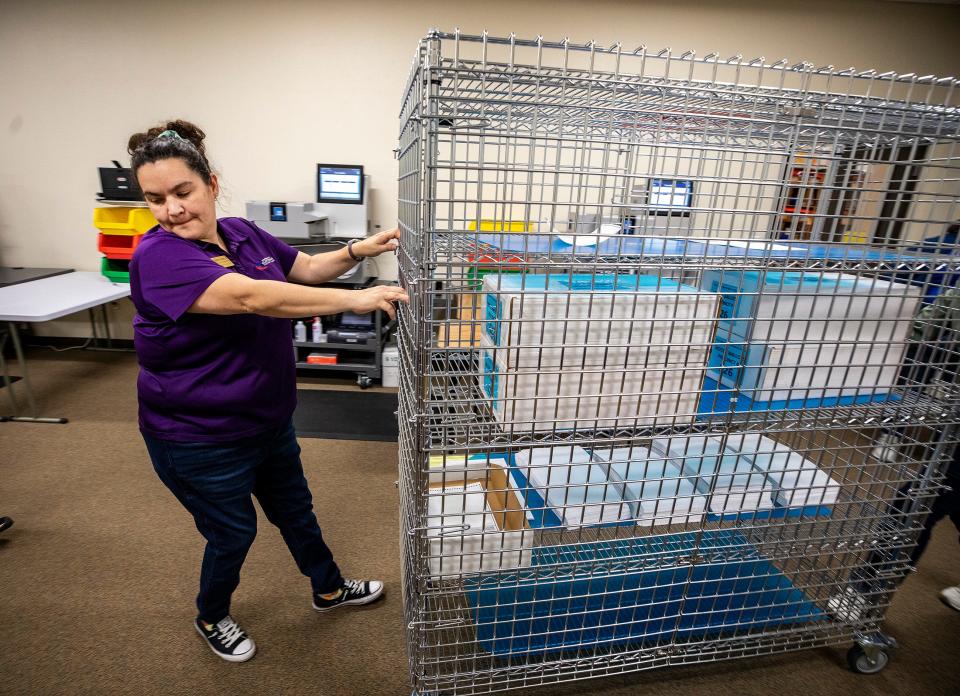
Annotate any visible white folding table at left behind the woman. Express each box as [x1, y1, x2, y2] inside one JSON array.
[[0, 271, 130, 423]]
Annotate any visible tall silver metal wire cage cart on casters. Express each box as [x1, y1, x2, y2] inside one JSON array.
[[398, 32, 960, 694]]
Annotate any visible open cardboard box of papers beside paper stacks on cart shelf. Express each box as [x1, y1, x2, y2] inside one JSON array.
[[427, 460, 534, 576]]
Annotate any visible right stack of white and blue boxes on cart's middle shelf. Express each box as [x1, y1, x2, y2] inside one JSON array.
[[701, 270, 921, 410]]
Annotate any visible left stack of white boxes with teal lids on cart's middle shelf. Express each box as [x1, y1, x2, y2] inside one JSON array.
[[481, 274, 718, 431]]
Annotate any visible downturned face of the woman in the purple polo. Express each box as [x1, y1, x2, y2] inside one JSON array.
[[137, 157, 219, 244]]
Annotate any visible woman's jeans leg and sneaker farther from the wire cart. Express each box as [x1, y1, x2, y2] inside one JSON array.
[[144, 435, 260, 662]]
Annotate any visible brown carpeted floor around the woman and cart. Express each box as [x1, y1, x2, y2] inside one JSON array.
[[0, 351, 960, 696]]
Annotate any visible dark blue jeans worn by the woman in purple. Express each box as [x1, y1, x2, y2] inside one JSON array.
[[143, 422, 343, 623]]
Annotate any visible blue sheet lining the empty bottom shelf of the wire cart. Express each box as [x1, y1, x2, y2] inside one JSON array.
[[466, 530, 826, 656]]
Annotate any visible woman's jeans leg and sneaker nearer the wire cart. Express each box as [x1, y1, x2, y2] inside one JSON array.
[[253, 423, 383, 611]]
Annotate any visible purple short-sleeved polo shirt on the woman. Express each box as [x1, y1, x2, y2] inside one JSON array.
[[130, 218, 297, 442]]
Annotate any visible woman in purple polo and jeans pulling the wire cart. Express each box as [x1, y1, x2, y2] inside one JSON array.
[[128, 121, 407, 662]]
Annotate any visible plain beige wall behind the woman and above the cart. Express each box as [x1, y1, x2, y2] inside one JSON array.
[[0, 0, 960, 336]]
